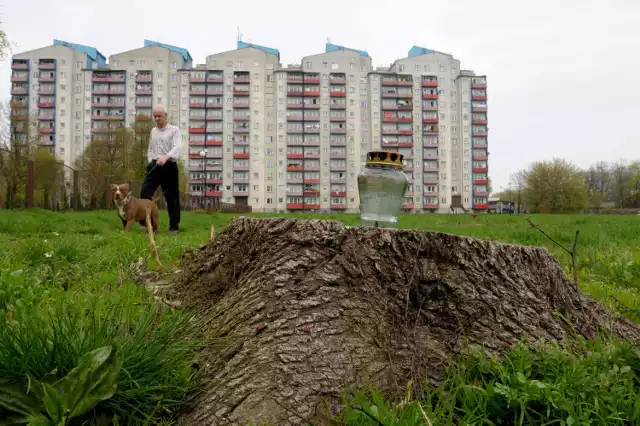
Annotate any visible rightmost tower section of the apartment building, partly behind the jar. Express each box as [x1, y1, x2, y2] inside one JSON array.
[[369, 46, 488, 213]]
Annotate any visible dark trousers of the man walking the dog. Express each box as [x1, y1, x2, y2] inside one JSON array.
[[140, 161, 180, 230]]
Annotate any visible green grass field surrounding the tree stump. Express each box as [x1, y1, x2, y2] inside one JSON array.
[[0, 210, 640, 425]]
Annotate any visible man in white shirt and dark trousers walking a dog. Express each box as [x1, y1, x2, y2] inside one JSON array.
[[140, 105, 183, 234]]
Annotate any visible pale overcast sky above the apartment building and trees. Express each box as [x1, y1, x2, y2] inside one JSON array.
[[0, 0, 640, 191]]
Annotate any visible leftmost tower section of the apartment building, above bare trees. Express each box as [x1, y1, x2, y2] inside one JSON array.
[[11, 40, 106, 164]]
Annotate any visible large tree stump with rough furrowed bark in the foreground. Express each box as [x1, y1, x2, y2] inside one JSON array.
[[173, 217, 640, 425]]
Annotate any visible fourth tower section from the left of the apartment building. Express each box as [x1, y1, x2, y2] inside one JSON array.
[[276, 44, 372, 211]]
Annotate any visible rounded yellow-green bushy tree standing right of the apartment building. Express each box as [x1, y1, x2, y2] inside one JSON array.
[[526, 158, 588, 213]]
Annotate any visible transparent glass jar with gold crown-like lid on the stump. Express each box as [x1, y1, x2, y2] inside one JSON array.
[[358, 151, 409, 228]]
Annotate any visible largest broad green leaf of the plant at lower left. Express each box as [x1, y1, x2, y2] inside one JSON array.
[[60, 345, 121, 418]]
